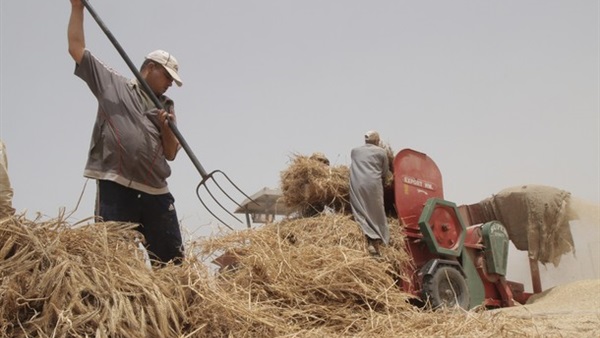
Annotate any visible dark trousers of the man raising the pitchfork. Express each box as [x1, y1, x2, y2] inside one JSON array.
[[96, 180, 183, 263]]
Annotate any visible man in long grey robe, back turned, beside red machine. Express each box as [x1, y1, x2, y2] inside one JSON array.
[[350, 131, 390, 256]]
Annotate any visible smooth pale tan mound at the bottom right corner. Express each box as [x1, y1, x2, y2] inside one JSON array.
[[494, 279, 600, 337]]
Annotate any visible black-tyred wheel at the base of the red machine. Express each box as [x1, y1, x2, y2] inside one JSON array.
[[423, 266, 469, 310]]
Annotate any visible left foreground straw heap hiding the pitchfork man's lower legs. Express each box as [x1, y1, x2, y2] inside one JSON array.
[[0, 218, 190, 337]]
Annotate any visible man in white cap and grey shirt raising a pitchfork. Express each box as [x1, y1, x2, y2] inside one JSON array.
[[67, 0, 183, 264]]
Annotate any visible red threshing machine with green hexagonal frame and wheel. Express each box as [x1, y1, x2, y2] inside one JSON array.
[[394, 149, 530, 308]]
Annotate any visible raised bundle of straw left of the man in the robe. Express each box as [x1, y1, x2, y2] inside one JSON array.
[[280, 154, 350, 216]]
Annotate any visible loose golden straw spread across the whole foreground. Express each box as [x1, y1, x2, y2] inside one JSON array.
[[0, 214, 548, 338]]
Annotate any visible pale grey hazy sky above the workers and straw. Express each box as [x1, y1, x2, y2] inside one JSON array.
[[0, 0, 600, 242]]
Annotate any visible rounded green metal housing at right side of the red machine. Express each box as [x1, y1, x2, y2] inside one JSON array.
[[481, 221, 509, 276]]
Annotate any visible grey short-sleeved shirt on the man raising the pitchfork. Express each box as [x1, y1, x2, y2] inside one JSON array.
[[75, 50, 173, 195]]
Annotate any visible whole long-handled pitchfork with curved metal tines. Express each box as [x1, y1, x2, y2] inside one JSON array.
[[81, 0, 252, 230]]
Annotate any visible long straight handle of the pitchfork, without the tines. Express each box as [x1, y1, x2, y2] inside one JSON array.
[[81, 0, 208, 179]]
